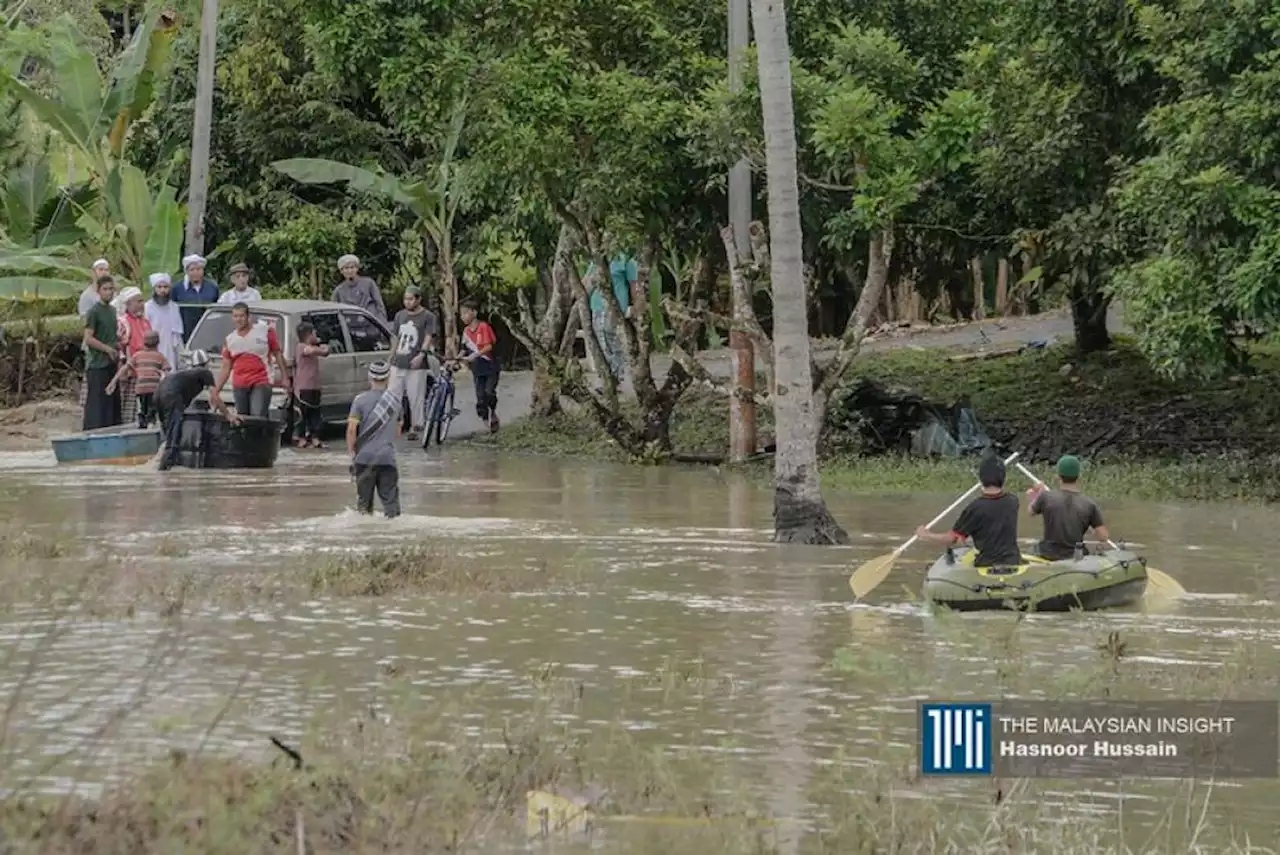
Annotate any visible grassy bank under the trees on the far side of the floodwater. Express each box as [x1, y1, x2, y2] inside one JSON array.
[[474, 339, 1280, 502]]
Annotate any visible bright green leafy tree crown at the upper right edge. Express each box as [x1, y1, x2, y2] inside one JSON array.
[[1115, 0, 1280, 378]]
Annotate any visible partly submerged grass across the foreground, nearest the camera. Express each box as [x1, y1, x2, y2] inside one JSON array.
[[0, 616, 1274, 855]]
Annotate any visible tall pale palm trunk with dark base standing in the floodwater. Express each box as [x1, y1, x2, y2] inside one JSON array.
[[751, 0, 849, 544]]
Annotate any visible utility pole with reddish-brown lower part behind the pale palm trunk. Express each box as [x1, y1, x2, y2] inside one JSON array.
[[728, 0, 755, 463]]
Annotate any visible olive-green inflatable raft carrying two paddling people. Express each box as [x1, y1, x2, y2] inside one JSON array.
[[924, 547, 1147, 612]]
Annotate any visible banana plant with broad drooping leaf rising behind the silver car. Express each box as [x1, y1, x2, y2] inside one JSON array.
[[271, 100, 466, 356]]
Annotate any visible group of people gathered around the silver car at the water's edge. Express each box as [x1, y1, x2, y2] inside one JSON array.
[[79, 255, 500, 458]]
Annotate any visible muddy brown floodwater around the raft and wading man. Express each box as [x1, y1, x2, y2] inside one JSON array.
[[0, 448, 1280, 842]]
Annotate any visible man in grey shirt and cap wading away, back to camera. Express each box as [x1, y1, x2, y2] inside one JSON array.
[[347, 361, 401, 520]]
